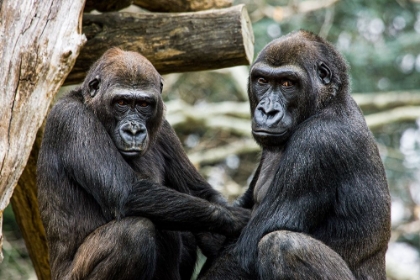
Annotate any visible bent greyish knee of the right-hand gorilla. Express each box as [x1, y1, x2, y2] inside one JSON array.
[[257, 231, 355, 280]]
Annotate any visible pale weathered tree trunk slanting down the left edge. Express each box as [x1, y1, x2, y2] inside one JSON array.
[[0, 0, 86, 266]]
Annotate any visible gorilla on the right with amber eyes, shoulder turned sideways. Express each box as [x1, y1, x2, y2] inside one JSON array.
[[200, 31, 390, 280]]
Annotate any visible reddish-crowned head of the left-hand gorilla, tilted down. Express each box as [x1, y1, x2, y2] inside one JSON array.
[[84, 49, 163, 158]]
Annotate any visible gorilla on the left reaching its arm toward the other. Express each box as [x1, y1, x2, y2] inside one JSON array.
[[37, 48, 249, 280]]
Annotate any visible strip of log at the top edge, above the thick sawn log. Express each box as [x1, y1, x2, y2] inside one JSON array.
[[134, 0, 233, 12]]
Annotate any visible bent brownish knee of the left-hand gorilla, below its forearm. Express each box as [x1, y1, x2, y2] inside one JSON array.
[[70, 217, 157, 280]]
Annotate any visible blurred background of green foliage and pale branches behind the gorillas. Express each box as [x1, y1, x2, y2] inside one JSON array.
[[0, 0, 420, 280]]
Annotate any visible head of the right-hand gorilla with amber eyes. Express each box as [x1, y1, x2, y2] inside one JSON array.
[[248, 31, 348, 147]]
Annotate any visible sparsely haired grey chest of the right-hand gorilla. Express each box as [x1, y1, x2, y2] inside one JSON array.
[[254, 151, 281, 209]]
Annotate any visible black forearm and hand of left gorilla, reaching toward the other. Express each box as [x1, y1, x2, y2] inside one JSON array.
[[126, 180, 249, 236]]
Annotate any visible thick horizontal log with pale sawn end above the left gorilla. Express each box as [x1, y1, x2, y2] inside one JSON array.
[[65, 5, 254, 84]]
